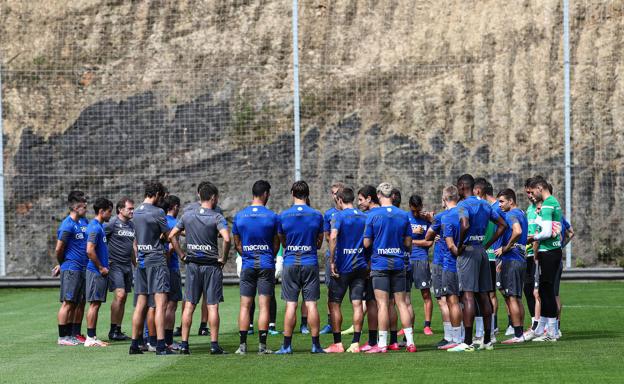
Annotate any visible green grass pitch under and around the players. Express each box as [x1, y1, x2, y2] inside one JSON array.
[[0, 282, 624, 383]]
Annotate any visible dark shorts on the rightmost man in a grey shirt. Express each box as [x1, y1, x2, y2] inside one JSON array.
[[185, 263, 223, 305]]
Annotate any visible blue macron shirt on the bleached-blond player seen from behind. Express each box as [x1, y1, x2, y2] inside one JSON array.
[[364, 206, 412, 271]]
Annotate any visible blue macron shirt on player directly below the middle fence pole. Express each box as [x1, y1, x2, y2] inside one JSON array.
[[278, 204, 323, 266]]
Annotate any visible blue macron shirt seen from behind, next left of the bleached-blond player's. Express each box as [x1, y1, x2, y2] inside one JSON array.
[[332, 208, 367, 273]]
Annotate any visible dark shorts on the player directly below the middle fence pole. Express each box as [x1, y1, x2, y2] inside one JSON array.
[[282, 265, 321, 302]]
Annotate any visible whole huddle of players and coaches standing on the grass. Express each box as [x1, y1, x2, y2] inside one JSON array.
[[54, 174, 573, 355]]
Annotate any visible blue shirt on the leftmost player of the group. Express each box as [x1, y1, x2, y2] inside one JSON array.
[[56, 215, 89, 271]]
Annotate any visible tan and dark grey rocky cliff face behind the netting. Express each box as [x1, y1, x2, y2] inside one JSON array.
[[0, 0, 624, 274]]
